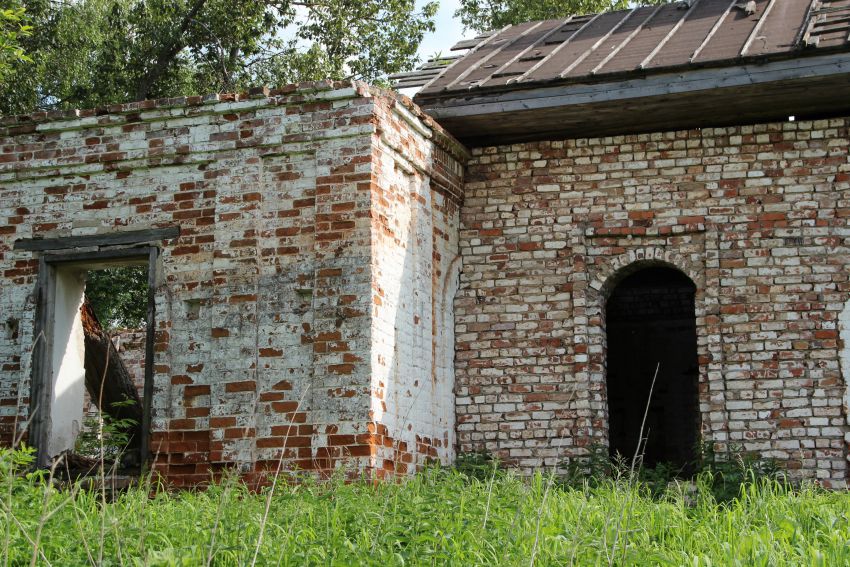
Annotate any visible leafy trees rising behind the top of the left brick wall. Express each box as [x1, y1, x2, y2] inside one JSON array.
[[0, 0, 437, 113]]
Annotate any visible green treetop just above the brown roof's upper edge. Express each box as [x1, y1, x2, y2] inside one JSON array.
[[455, 0, 671, 32]]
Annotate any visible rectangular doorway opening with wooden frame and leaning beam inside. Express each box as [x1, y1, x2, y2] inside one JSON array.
[[29, 246, 158, 474]]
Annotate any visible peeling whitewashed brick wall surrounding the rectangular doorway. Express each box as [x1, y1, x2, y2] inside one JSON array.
[[0, 83, 457, 484]]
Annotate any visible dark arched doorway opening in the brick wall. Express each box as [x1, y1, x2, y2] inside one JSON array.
[[605, 266, 699, 474]]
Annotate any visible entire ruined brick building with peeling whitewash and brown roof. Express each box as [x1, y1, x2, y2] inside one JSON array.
[[0, 0, 850, 488]]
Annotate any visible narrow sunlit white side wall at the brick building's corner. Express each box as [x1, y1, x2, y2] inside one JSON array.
[[371, 101, 466, 472]]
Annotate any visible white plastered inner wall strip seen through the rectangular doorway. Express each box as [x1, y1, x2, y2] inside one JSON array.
[[47, 268, 86, 457]]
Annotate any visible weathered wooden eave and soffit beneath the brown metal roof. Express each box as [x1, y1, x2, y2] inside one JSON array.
[[417, 50, 850, 146]]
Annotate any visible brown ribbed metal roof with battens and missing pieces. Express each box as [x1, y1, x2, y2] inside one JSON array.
[[396, 0, 850, 98]]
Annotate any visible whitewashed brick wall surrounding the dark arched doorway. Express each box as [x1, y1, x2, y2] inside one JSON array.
[[455, 119, 850, 487]]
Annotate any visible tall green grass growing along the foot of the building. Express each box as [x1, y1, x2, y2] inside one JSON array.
[[0, 451, 850, 567]]
